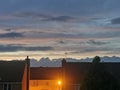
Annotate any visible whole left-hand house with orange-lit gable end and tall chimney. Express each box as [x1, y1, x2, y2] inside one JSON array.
[[0, 57, 29, 90]]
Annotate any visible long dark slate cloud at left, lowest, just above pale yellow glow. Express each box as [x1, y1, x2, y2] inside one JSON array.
[[0, 44, 53, 52]]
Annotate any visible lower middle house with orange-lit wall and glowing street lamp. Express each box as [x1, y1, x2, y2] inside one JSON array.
[[30, 67, 62, 90]]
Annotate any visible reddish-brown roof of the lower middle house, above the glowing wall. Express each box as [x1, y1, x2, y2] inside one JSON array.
[[30, 67, 62, 80]]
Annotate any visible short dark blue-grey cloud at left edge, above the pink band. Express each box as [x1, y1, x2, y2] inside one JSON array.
[[0, 32, 24, 38]]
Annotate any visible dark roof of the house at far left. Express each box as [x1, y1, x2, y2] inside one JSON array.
[[0, 61, 26, 82]]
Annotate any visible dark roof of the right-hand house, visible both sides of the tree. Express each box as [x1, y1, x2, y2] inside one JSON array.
[[63, 62, 120, 84]]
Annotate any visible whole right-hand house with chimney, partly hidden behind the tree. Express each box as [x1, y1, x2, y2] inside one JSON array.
[[62, 59, 120, 90]]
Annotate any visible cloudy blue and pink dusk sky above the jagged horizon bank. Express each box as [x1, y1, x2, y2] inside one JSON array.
[[0, 0, 120, 60]]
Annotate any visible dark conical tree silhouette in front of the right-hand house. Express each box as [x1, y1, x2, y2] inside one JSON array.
[[80, 56, 120, 90]]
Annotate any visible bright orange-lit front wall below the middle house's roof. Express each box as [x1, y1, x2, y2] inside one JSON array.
[[29, 80, 62, 90]]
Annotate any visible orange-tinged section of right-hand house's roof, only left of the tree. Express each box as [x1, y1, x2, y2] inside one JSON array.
[[63, 62, 91, 84]]
